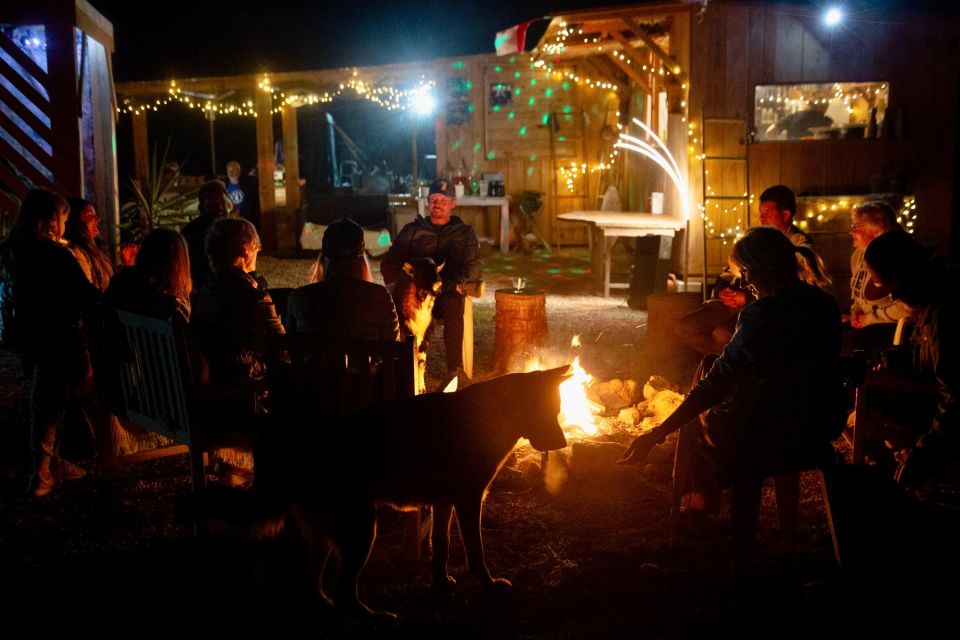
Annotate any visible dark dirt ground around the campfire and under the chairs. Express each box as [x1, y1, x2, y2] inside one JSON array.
[[0, 249, 960, 638]]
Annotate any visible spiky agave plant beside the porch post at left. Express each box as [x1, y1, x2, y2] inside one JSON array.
[[124, 140, 199, 240]]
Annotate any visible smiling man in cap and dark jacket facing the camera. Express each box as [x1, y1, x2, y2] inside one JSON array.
[[380, 179, 483, 373]]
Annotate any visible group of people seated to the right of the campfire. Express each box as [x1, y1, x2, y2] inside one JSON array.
[[622, 185, 960, 511]]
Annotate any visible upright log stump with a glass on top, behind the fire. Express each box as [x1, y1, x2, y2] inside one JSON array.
[[493, 289, 547, 371]]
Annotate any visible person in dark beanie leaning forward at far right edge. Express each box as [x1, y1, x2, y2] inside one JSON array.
[[865, 231, 960, 488]]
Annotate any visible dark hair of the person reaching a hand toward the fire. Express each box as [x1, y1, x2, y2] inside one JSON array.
[[730, 227, 830, 290]]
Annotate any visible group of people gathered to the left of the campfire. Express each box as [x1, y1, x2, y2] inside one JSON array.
[[0, 180, 482, 497]]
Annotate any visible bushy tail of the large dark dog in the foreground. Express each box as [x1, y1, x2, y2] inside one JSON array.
[[176, 487, 287, 538]]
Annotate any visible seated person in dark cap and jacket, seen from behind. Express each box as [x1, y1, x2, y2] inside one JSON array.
[[286, 218, 400, 340]]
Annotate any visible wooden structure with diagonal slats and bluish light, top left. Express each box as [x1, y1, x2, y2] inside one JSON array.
[[0, 0, 119, 255]]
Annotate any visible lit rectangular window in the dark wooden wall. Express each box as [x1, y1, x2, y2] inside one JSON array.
[[754, 82, 890, 142]]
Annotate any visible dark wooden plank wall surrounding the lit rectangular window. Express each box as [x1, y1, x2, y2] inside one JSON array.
[[690, 2, 960, 272]]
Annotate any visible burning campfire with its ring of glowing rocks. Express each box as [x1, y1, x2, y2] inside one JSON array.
[[514, 335, 683, 492]]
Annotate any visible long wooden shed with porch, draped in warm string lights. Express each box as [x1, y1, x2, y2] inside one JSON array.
[[118, 0, 960, 295]]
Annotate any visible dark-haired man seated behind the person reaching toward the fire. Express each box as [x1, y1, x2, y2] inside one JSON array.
[[674, 185, 822, 355]]
